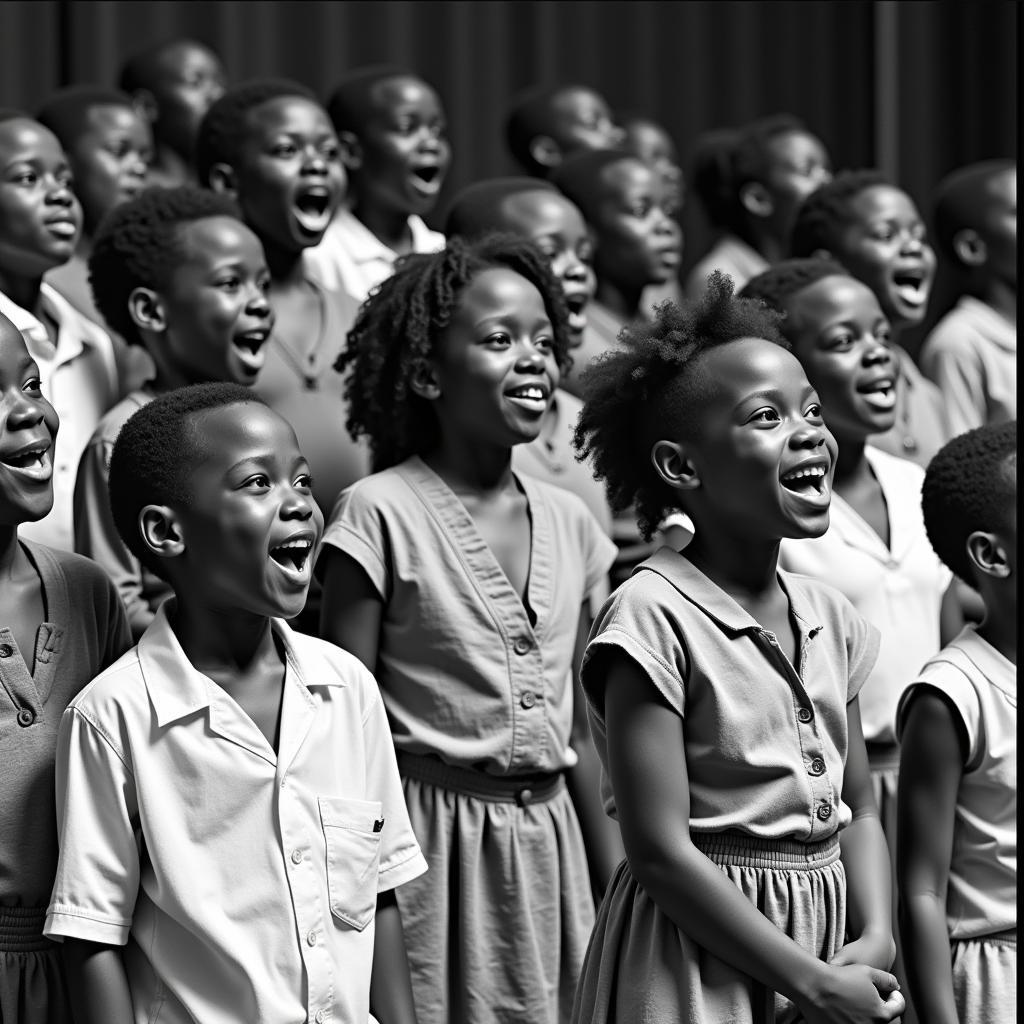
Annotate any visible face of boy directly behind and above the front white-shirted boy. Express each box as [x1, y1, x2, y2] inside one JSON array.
[[157, 217, 273, 384]]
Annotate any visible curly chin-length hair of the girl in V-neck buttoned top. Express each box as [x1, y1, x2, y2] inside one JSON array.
[[335, 234, 570, 471]]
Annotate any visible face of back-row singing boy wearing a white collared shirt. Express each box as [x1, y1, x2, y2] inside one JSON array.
[[349, 76, 452, 216]]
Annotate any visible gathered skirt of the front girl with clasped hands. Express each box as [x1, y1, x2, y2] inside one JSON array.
[[572, 833, 846, 1024]]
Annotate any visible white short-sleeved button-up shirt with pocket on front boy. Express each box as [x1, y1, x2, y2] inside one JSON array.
[[45, 601, 426, 1024]]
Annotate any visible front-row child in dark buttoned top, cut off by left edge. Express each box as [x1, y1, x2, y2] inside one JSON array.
[[0, 314, 129, 1024]]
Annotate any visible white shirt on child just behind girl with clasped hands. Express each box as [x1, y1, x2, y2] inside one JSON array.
[[779, 445, 952, 743]]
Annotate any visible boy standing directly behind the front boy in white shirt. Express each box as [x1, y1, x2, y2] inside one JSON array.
[[75, 185, 273, 640]]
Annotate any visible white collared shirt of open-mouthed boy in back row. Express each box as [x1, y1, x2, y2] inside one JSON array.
[[303, 208, 444, 303]]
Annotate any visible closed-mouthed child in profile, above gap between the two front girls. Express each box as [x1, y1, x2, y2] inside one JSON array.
[[552, 150, 682, 395]]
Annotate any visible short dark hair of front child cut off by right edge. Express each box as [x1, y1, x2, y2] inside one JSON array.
[[921, 420, 1017, 587]]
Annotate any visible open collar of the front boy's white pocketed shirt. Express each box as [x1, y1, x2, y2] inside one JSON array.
[[138, 597, 347, 728]]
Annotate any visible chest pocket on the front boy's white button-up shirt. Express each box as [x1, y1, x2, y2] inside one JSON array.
[[316, 797, 384, 932]]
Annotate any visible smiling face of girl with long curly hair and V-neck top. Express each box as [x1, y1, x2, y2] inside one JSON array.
[[431, 267, 558, 447]]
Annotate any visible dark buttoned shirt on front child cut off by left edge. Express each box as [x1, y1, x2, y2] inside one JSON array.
[[0, 541, 131, 907]]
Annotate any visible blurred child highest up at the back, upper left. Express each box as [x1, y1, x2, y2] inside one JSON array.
[[120, 39, 224, 186]]
